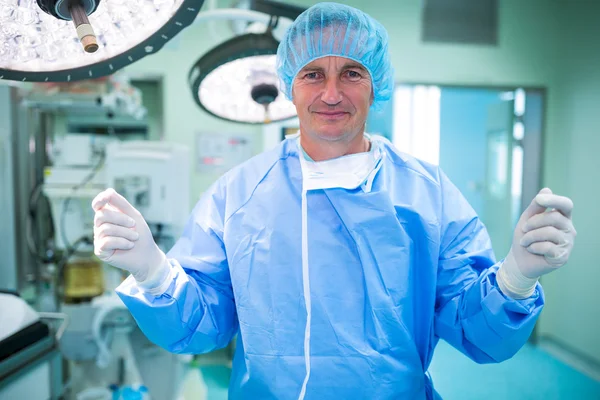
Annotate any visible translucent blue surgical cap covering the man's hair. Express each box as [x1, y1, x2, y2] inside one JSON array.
[[277, 3, 394, 110]]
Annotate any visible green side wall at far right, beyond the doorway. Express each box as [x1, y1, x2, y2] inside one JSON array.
[[538, 1, 600, 362]]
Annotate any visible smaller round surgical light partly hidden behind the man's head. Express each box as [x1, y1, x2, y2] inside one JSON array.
[[188, 0, 304, 124]]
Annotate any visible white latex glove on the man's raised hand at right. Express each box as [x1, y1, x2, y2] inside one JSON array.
[[497, 188, 577, 299]]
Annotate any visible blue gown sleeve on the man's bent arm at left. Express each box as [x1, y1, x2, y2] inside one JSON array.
[[117, 181, 238, 354]]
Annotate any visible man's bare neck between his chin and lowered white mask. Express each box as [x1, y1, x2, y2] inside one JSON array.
[[300, 130, 370, 161]]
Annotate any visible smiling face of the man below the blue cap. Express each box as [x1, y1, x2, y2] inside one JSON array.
[[292, 56, 373, 141]]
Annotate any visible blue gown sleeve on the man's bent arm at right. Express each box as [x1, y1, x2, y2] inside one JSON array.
[[434, 171, 544, 363]]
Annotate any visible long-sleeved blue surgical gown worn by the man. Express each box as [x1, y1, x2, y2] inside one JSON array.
[[117, 137, 544, 400]]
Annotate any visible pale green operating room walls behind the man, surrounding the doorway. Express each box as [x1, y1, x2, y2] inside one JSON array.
[[128, 0, 600, 362]]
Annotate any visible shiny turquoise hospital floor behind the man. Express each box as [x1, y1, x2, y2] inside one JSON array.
[[193, 341, 600, 400]]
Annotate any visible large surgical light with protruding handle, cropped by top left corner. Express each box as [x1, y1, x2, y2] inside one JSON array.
[[0, 0, 204, 82]]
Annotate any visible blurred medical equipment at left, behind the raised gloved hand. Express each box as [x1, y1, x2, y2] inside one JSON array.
[[0, 75, 191, 399]]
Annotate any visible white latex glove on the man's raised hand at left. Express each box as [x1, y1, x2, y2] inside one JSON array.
[[92, 189, 170, 289]]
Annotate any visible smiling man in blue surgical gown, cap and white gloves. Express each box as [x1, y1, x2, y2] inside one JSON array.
[[93, 3, 575, 399]]
